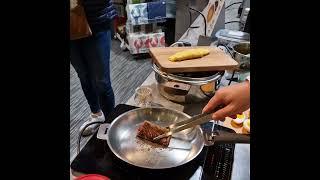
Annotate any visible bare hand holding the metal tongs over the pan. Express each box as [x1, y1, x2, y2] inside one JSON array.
[[202, 81, 250, 120]]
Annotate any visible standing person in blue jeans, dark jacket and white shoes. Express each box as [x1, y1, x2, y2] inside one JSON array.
[[70, 0, 116, 135]]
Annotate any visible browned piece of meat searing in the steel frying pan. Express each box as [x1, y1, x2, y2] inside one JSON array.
[[137, 121, 171, 147]]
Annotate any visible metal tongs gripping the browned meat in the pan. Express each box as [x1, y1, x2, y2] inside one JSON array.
[[153, 113, 213, 141]]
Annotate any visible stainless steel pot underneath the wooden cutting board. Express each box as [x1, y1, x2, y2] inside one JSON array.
[[152, 63, 224, 103]]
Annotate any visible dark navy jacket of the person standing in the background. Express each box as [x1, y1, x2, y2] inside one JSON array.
[[81, 0, 117, 33]]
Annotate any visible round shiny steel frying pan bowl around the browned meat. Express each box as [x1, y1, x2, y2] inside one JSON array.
[[107, 108, 204, 169]]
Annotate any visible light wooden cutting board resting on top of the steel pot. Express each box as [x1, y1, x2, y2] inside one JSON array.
[[149, 46, 238, 73]]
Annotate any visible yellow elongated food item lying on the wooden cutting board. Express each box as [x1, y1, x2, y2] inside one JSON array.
[[169, 48, 210, 62]]
